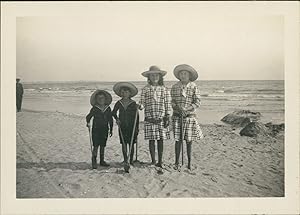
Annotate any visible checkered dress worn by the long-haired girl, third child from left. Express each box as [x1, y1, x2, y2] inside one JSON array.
[[139, 84, 172, 140]]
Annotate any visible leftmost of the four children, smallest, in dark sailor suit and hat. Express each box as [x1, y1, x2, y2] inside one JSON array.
[[86, 90, 113, 169]]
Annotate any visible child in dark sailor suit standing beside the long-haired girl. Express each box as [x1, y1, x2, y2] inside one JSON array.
[[112, 82, 139, 165]]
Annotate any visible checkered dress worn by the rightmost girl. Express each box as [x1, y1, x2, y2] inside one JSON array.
[[171, 81, 203, 142]]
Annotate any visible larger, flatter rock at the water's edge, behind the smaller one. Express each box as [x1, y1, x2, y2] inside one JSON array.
[[221, 110, 261, 127]]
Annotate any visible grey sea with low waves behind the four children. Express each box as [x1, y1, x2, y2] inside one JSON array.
[[22, 80, 285, 124]]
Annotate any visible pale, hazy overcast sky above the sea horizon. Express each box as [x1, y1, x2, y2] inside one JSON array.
[[16, 3, 284, 81]]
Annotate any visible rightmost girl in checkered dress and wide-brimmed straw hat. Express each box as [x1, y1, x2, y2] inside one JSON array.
[[171, 64, 203, 170]]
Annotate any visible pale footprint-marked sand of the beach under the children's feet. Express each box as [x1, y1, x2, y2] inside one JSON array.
[[16, 110, 284, 198]]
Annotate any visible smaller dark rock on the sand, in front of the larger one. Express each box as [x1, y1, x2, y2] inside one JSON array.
[[240, 122, 270, 137]]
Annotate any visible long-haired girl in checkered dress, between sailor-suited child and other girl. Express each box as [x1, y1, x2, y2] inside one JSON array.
[[139, 66, 172, 167]]
